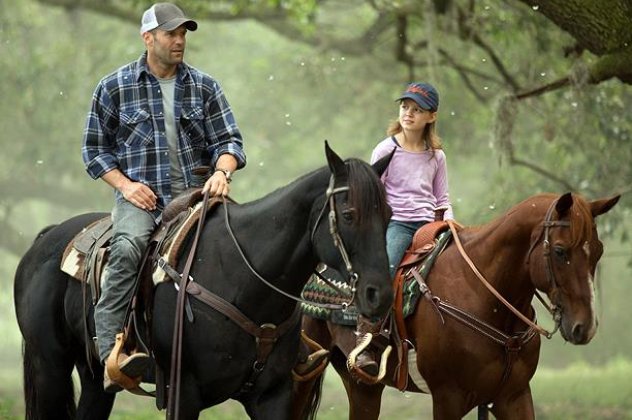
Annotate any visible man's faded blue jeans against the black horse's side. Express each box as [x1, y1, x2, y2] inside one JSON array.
[[94, 199, 156, 362]]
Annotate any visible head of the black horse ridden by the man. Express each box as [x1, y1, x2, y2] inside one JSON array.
[[312, 143, 393, 317]]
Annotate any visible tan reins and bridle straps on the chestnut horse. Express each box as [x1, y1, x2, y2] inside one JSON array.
[[447, 202, 570, 339]]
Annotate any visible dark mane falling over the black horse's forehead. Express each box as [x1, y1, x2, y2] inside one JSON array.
[[345, 158, 391, 226]]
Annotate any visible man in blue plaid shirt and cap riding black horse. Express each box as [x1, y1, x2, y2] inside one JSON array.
[[82, 3, 246, 392]]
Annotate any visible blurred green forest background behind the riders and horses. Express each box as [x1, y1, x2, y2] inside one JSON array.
[[0, 0, 632, 419]]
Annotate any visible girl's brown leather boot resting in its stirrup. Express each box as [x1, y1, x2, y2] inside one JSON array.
[[347, 315, 391, 384]]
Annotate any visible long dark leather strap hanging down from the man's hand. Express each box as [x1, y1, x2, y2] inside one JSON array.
[[167, 191, 208, 420]]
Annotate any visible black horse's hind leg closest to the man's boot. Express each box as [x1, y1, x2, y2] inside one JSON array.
[[77, 362, 116, 420]]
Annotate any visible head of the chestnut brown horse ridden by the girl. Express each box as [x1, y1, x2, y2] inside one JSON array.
[[529, 193, 620, 344]]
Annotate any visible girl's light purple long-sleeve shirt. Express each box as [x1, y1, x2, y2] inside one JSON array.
[[371, 137, 454, 222]]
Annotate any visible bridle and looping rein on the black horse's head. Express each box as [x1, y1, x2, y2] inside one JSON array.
[[223, 173, 359, 310]]
